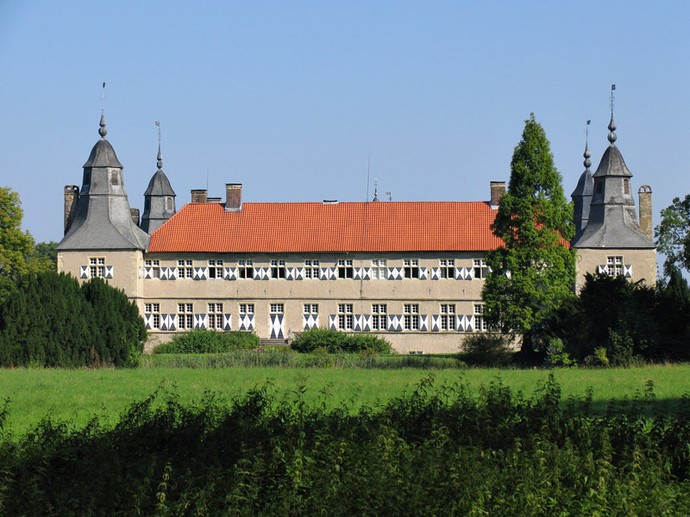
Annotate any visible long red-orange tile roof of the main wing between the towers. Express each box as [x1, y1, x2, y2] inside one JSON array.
[[148, 201, 501, 253]]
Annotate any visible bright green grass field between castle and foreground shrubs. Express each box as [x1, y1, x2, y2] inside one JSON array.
[[0, 365, 690, 434]]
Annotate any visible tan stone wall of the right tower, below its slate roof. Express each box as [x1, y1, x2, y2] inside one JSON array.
[[575, 248, 657, 292]]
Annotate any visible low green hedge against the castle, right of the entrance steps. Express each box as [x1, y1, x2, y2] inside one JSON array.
[[291, 328, 393, 354]]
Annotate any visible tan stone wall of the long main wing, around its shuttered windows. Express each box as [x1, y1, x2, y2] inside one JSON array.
[[137, 253, 490, 353]]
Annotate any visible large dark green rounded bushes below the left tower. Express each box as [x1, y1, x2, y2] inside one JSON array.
[[0, 272, 146, 368]]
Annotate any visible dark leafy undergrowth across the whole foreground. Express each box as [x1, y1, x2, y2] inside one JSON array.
[[0, 378, 690, 516]]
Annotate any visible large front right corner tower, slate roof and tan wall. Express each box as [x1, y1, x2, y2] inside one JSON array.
[[572, 111, 656, 290]]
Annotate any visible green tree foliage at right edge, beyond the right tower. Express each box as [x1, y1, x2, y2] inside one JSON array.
[[655, 194, 690, 276]]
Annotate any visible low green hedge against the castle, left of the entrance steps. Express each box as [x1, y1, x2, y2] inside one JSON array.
[[153, 329, 261, 354]]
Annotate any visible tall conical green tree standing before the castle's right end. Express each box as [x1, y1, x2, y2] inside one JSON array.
[[482, 114, 575, 346]]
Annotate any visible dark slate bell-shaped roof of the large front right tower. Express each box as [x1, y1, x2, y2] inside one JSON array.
[[573, 114, 654, 249]]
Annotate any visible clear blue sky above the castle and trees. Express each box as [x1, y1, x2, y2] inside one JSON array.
[[0, 0, 690, 245]]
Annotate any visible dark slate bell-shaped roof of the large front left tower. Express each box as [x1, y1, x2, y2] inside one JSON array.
[[58, 114, 149, 251]]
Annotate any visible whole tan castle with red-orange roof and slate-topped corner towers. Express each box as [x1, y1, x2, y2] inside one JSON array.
[[58, 109, 655, 353]]
